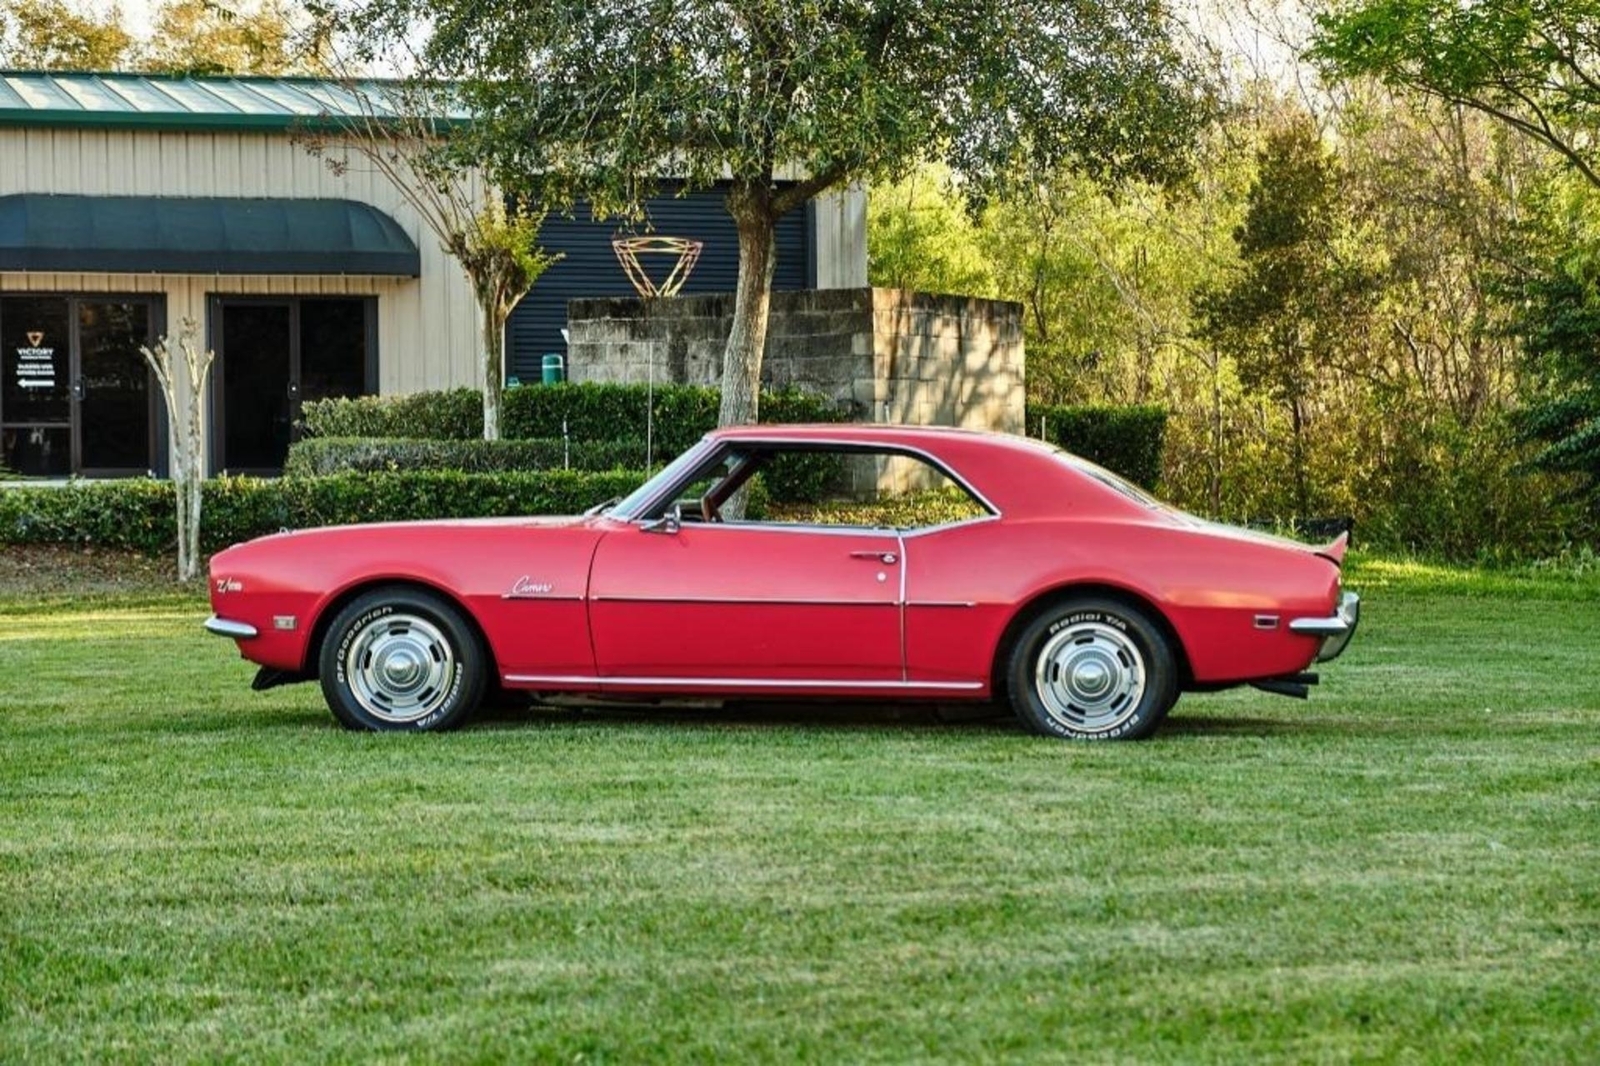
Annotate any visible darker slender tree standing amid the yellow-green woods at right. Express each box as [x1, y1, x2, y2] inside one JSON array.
[[1198, 115, 1374, 514]]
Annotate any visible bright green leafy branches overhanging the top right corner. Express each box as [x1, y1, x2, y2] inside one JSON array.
[[1310, 0, 1600, 186]]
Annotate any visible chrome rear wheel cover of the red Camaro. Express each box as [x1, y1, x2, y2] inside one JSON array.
[[1034, 621, 1147, 733]]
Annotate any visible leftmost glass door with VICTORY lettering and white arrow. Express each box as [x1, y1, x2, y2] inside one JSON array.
[[0, 296, 72, 477]]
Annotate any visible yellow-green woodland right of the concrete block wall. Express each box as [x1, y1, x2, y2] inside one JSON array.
[[870, 78, 1600, 559]]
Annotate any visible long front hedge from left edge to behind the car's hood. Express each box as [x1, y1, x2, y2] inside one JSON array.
[[0, 471, 645, 554]]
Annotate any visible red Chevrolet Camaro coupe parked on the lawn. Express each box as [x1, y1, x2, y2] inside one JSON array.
[[206, 426, 1358, 739]]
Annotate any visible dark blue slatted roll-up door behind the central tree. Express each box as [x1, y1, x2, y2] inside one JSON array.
[[507, 189, 813, 383]]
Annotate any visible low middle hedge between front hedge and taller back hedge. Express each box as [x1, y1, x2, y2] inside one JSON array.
[[283, 437, 645, 477]]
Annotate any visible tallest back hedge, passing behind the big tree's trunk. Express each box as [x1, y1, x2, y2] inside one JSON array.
[[302, 384, 845, 458]]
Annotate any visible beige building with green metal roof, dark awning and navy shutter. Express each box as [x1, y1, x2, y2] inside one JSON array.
[[0, 70, 866, 475]]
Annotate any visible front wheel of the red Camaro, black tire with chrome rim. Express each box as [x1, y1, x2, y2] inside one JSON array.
[[317, 586, 488, 731]]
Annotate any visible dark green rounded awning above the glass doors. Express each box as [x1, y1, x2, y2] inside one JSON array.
[[0, 192, 422, 277]]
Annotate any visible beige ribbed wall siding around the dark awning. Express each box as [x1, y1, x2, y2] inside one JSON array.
[[0, 130, 478, 394]]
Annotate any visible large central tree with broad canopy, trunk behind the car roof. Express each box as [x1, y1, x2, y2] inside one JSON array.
[[347, 0, 1200, 423]]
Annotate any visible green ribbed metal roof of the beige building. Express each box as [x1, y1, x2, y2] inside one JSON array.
[[0, 70, 466, 131]]
